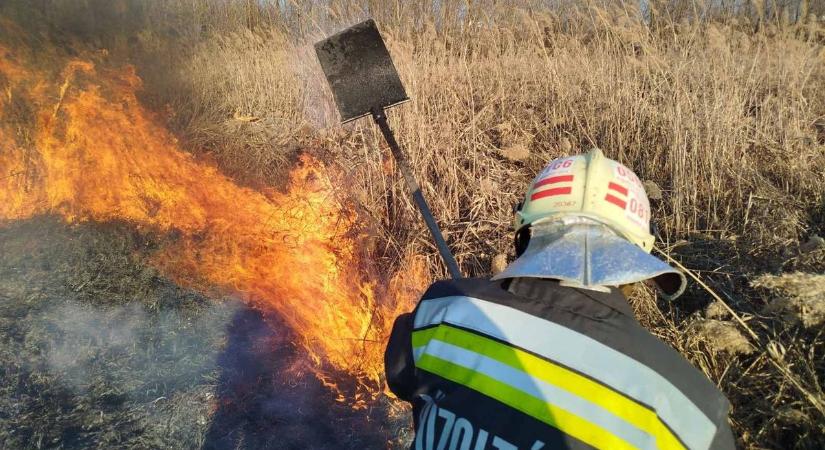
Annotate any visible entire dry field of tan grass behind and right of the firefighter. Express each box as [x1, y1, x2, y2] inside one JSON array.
[[0, 0, 825, 449]]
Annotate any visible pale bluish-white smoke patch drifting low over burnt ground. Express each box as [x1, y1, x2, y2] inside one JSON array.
[[39, 301, 241, 402]]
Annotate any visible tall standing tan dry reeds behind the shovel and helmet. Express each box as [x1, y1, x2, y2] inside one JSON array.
[[137, 4, 825, 268]]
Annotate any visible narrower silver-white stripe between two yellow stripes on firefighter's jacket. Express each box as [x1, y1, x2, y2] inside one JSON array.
[[425, 339, 656, 448]]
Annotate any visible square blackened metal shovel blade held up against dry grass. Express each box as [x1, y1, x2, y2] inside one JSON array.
[[315, 19, 409, 123]]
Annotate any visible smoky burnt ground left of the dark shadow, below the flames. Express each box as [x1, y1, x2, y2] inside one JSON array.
[[0, 216, 232, 448]]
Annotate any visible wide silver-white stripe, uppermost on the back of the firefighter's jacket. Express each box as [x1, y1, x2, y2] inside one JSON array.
[[414, 296, 716, 449]]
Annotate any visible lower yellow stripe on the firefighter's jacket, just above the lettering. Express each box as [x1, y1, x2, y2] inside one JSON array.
[[416, 354, 635, 449]]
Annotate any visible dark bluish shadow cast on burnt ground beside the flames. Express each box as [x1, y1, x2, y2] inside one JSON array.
[[204, 309, 396, 449]]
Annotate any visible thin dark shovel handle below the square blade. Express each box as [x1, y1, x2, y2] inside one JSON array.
[[372, 108, 462, 280]]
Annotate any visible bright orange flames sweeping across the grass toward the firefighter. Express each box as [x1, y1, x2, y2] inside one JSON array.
[[0, 47, 426, 404]]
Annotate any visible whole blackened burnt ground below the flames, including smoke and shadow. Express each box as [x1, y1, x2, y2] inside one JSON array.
[[0, 217, 400, 449]]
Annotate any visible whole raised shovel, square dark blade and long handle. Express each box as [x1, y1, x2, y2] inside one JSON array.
[[315, 19, 461, 279]]
